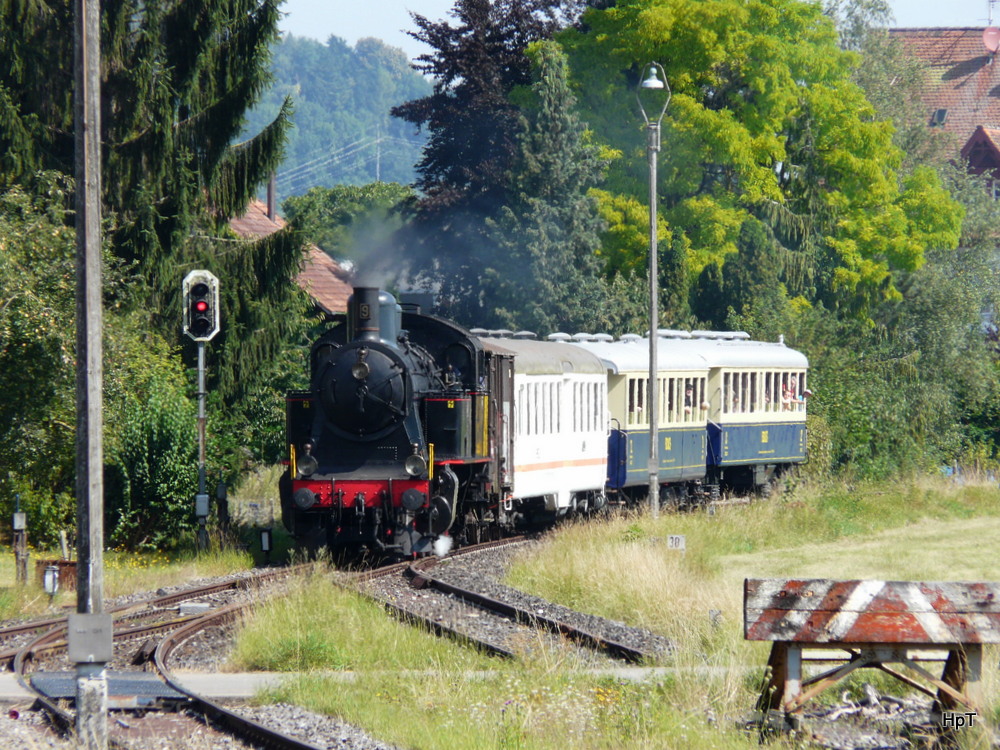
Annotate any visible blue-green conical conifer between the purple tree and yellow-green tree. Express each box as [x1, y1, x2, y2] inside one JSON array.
[[481, 42, 609, 334]]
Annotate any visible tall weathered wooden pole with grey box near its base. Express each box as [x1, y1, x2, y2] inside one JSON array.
[[69, 0, 111, 750]]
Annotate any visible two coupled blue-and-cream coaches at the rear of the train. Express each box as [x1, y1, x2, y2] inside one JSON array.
[[566, 330, 808, 502]]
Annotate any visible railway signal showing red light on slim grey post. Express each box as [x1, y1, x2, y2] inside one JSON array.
[[183, 270, 219, 550]]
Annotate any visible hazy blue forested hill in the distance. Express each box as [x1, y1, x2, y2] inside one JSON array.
[[247, 35, 431, 202]]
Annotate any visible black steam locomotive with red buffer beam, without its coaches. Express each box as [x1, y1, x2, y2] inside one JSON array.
[[280, 288, 511, 557]]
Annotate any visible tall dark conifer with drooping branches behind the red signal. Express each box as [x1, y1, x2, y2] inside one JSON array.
[[0, 0, 301, 402]]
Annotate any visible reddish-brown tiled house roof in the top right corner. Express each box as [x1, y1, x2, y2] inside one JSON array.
[[889, 27, 1000, 145]]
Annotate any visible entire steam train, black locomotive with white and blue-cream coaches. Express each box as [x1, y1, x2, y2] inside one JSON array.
[[279, 287, 808, 558]]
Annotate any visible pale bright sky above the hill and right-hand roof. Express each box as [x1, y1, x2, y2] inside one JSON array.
[[280, 0, 1000, 58]]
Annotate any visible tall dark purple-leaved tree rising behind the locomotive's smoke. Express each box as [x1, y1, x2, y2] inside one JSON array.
[[392, 0, 580, 325]]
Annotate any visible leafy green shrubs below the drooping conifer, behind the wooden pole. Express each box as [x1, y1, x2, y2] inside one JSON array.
[[0, 178, 209, 545]]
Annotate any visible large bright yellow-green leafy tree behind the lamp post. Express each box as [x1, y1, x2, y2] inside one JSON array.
[[558, 0, 960, 316]]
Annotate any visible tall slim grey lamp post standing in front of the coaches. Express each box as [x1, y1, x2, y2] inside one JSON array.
[[635, 62, 670, 518]]
